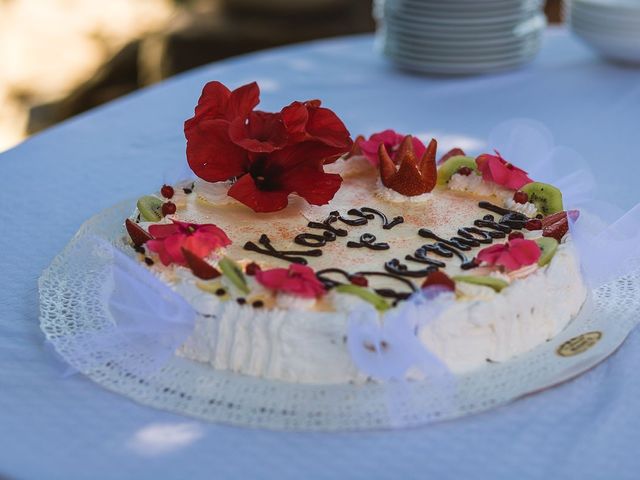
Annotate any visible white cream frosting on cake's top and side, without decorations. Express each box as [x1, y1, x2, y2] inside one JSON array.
[[134, 159, 587, 384]]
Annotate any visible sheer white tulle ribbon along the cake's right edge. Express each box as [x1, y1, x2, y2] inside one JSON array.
[[489, 119, 640, 288]]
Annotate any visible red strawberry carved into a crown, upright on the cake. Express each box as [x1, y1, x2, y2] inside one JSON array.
[[378, 135, 438, 197]]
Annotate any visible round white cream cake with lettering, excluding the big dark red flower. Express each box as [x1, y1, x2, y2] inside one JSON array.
[[122, 80, 587, 384]]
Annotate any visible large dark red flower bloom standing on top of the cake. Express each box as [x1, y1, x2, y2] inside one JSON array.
[[185, 82, 353, 212]]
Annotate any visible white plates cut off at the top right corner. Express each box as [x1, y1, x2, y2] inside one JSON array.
[[568, 0, 640, 64]]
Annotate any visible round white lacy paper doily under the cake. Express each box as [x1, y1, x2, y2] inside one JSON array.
[[39, 201, 640, 431]]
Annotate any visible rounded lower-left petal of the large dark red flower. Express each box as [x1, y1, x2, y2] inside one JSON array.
[[185, 119, 248, 182]]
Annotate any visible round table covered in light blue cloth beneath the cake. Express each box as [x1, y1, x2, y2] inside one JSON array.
[[0, 29, 640, 480]]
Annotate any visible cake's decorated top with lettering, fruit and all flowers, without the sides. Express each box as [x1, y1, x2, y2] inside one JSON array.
[[127, 82, 573, 316]]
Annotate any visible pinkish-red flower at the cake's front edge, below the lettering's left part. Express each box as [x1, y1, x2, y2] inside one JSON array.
[[256, 263, 326, 298]]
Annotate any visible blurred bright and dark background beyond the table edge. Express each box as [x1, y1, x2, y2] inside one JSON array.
[[0, 0, 560, 152]]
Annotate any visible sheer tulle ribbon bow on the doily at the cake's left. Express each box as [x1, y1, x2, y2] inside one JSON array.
[[61, 236, 196, 375]]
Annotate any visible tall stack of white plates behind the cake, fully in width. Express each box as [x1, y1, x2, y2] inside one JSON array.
[[374, 0, 546, 75]]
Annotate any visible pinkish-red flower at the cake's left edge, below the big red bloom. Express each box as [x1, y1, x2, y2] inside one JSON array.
[[146, 220, 231, 265]]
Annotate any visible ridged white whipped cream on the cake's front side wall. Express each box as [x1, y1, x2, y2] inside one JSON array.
[[178, 244, 587, 384]]
